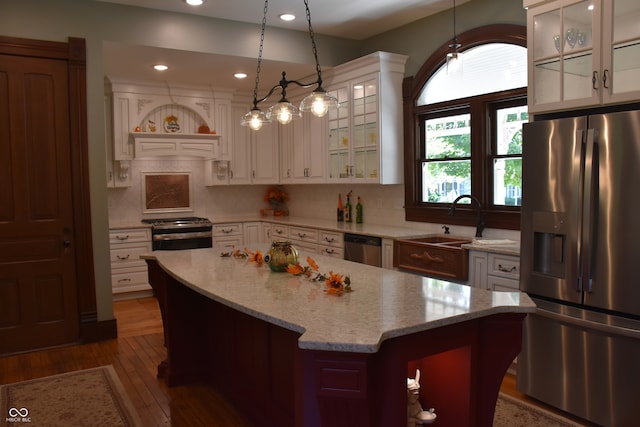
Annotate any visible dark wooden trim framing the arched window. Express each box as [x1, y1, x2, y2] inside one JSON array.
[[402, 24, 527, 230]]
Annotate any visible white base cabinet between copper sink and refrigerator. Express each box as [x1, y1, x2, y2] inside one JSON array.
[[469, 250, 520, 292]]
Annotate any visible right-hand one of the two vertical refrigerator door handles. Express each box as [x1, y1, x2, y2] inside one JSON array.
[[579, 129, 598, 292]]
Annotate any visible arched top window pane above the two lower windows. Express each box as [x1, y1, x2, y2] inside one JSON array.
[[416, 43, 527, 105]]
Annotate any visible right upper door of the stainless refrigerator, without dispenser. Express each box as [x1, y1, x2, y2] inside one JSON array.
[[584, 111, 640, 316]]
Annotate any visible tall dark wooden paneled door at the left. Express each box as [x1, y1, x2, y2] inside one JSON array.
[[0, 46, 79, 354]]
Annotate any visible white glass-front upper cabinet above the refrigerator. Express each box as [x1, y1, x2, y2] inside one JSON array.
[[524, 0, 640, 113]]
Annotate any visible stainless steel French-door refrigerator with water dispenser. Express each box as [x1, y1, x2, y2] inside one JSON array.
[[517, 111, 640, 426]]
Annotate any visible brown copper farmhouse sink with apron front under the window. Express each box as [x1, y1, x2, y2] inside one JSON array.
[[393, 236, 471, 282]]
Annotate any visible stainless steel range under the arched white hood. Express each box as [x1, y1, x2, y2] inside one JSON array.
[[142, 217, 212, 251]]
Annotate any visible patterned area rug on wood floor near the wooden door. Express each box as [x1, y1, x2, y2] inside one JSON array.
[[0, 365, 142, 427]]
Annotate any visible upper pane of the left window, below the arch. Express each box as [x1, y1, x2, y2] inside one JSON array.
[[425, 114, 471, 159]]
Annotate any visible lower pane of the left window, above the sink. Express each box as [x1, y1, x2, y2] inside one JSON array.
[[422, 160, 471, 203]]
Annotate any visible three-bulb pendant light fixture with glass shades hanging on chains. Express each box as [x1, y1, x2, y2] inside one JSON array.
[[240, 0, 339, 130]]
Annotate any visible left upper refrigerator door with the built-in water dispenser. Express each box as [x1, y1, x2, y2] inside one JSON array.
[[520, 117, 587, 303]]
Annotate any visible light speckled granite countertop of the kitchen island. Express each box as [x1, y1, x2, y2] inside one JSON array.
[[142, 245, 535, 353]]
